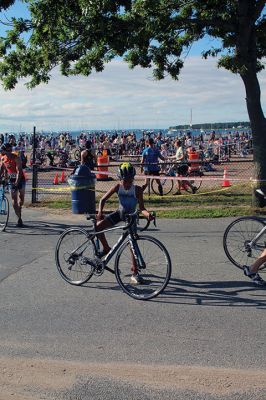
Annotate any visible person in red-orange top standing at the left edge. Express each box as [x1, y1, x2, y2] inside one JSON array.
[[0, 143, 26, 228]]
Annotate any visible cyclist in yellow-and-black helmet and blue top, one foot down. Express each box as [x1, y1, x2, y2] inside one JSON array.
[[96, 162, 153, 284]]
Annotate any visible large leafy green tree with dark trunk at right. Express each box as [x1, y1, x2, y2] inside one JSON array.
[[0, 0, 266, 198]]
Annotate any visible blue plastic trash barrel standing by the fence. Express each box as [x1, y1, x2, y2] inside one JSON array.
[[68, 165, 96, 214]]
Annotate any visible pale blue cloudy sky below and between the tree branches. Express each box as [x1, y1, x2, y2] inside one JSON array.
[[0, 2, 266, 132]]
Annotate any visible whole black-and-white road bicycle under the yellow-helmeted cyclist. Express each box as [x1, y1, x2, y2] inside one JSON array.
[[55, 211, 172, 300]]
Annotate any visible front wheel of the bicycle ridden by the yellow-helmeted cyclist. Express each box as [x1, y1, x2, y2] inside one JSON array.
[[115, 236, 172, 300]]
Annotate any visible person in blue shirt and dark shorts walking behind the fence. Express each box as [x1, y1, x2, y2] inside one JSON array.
[[141, 138, 165, 196]]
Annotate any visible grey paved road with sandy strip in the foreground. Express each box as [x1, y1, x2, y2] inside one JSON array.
[[0, 209, 266, 400]]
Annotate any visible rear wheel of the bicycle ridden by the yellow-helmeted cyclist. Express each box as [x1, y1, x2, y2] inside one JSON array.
[[55, 228, 95, 286]]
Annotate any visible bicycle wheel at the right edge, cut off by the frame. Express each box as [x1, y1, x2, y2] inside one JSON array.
[[223, 217, 265, 269]]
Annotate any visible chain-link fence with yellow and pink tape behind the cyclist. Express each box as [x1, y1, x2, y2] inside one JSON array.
[[23, 155, 254, 207]]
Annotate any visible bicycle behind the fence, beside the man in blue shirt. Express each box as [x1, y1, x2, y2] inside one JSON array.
[[151, 164, 203, 195]]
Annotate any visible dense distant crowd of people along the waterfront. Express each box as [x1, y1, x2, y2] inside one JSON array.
[[0, 131, 252, 169]]
